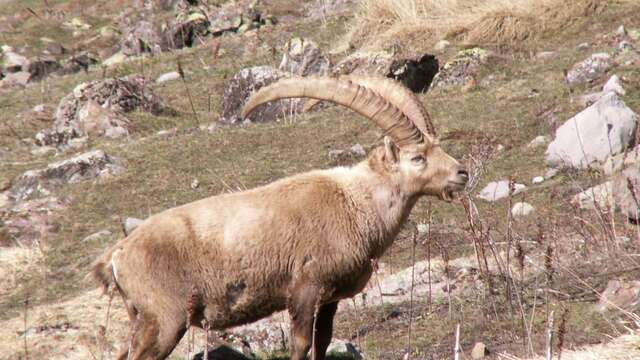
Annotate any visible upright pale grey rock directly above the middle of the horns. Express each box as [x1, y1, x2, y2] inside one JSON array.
[[278, 37, 331, 76]]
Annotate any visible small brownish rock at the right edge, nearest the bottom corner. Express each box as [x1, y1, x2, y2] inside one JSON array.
[[596, 280, 640, 313]]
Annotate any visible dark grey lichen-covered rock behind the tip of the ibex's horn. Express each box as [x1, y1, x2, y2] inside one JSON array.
[[219, 66, 303, 124]]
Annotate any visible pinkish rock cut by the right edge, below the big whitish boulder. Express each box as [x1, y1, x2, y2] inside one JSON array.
[[613, 162, 640, 224]]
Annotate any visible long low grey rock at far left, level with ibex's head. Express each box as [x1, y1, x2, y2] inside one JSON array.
[[10, 150, 123, 202]]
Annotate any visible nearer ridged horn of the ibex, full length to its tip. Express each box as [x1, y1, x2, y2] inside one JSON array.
[[241, 77, 425, 146]]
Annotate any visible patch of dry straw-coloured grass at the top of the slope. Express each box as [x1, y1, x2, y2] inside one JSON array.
[[348, 0, 607, 49]]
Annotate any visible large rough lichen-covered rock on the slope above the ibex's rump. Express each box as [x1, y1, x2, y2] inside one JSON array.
[[36, 75, 164, 146]]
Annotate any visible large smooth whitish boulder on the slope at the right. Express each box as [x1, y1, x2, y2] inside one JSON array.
[[545, 92, 638, 168]]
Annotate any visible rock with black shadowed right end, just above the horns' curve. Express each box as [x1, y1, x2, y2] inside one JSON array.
[[332, 52, 438, 92]]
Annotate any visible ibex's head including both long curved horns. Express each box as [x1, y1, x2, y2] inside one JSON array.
[[242, 75, 469, 201]]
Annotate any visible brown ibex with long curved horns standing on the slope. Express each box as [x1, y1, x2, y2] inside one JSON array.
[[93, 76, 468, 360]]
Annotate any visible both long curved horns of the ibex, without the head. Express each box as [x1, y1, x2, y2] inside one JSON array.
[[241, 75, 435, 146]]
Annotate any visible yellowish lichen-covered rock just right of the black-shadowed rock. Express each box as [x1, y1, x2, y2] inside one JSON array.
[[432, 48, 491, 87]]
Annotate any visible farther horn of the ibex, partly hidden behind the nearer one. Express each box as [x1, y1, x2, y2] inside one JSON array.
[[340, 75, 436, 137]]
